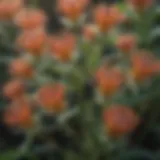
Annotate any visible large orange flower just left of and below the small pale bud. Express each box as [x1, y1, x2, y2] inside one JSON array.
[[50, 33, 76, 62]]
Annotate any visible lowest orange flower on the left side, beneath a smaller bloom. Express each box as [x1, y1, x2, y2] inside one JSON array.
[[4, 99, 33, 128]]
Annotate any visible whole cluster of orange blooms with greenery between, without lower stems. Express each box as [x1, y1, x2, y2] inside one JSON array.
[[0, 0, 160, 158]]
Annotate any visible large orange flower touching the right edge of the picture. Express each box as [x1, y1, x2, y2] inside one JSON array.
[[132, 51, 160, 81]]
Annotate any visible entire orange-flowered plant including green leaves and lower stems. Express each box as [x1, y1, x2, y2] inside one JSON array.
[[0, 0, 160, 160]]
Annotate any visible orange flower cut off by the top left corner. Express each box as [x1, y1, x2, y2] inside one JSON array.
[[0, 0, 24, 20]]
